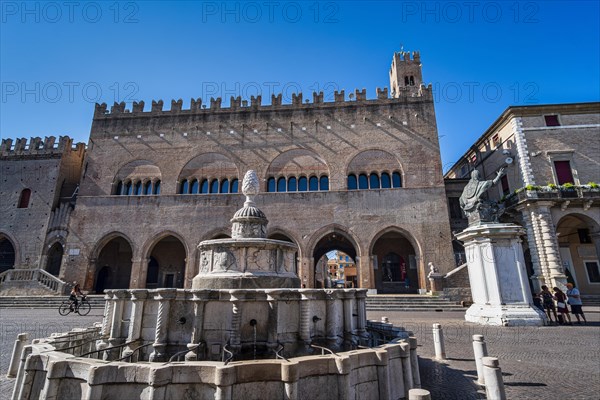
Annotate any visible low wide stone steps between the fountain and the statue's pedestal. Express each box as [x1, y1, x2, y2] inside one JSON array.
[[366, 294, 466, 311]]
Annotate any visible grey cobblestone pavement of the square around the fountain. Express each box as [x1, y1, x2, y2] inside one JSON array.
[[0, 307, 600, 400]]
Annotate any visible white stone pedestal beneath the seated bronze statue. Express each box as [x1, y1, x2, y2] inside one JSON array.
[[456, 223, 546, 326]]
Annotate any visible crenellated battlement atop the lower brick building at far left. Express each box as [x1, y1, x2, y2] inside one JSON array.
[[0, 136, 86, 157]]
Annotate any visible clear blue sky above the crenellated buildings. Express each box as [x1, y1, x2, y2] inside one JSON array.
[[0, 0, 600, 170]]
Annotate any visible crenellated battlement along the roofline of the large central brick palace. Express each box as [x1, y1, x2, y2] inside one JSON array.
[[94, 86, 433, 119]]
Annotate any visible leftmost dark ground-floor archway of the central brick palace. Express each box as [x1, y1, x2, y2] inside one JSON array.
[[94, 236, 133, 293]]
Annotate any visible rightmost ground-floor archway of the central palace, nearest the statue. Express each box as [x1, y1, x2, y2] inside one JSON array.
[[371, 230, 422, 294]]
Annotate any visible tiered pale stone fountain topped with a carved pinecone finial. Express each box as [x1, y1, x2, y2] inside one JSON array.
[[13, 171, 420, 399]]
